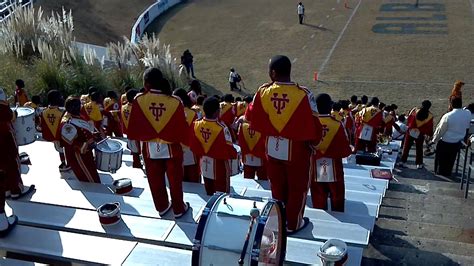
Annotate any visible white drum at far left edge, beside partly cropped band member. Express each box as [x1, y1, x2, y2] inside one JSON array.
[[12, 107, 36, 146]]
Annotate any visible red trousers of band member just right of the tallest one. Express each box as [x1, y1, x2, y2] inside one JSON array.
[[311, 181, 345, 212]]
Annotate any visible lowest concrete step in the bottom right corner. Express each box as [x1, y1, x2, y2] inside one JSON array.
[[362, 245, 474, 266]]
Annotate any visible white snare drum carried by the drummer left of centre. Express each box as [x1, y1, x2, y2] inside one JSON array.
[[95, 139, 123, 173]]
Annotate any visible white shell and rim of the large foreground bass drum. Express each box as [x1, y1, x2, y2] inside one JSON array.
[[192, 193, 286, 265]]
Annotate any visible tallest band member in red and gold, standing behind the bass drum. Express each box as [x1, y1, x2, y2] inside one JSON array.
[[245, 55, 322, 233]]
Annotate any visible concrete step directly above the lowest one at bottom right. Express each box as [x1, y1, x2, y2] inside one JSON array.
[[373, 218, 474, 244]]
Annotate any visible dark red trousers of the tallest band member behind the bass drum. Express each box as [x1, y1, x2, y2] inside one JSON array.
[[267, 142, 310, 230]]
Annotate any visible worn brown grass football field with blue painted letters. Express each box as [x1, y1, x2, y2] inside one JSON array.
[[149, 0, 474, 118]]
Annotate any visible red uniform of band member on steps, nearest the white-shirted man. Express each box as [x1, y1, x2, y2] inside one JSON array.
[[401, 108, 433, 165]]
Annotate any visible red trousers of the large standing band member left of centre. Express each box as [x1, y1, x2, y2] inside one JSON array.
[[144, 156, 185, 214]]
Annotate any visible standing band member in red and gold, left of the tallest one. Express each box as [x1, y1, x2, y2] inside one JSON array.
[[128, 68, 189, 218]]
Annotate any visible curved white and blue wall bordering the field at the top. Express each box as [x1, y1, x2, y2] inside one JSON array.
[[130, 0, 185, 43]]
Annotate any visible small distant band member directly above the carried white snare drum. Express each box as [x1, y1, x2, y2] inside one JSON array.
[[104, 91, 123, 137]]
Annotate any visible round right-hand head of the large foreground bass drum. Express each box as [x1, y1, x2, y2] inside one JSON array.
[[252, 201, 286, 265]]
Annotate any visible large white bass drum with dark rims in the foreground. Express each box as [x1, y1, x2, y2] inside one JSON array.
[[192, 193, 286, 266]]
